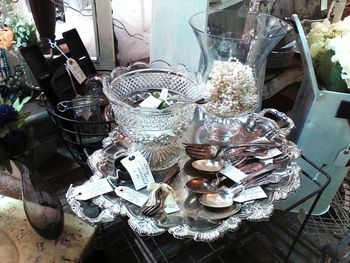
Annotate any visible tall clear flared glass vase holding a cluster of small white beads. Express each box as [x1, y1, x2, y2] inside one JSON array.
[[189, 8, 291, 143]]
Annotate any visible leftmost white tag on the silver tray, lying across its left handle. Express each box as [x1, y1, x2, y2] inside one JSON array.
[[74, 178, 113, 200]]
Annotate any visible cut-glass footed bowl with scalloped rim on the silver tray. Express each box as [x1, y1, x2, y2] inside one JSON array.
[[103, 62, 200, 170]]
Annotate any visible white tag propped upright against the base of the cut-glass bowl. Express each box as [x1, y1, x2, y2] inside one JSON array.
[[121, 152, 154, 190]]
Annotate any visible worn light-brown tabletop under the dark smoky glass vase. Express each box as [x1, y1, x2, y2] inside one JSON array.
[[0, 196, 96, 263]]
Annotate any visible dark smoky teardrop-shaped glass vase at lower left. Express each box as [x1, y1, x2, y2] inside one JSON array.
[[16, 161, 64, 239]]
